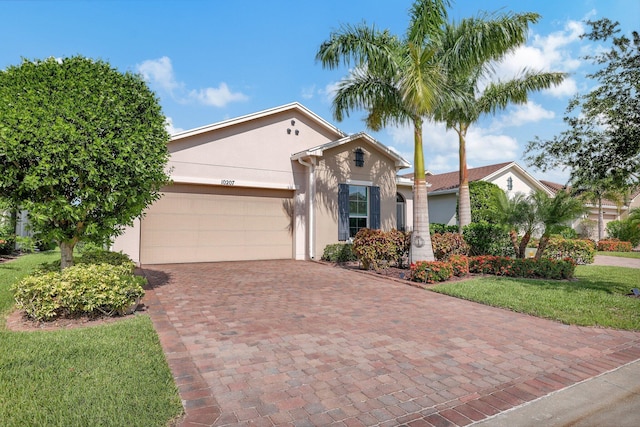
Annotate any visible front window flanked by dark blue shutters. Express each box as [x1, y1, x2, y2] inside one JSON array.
[[338, 184, 380, 241]]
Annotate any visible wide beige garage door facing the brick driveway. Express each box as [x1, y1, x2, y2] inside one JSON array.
[[140, 184, 293, 264]]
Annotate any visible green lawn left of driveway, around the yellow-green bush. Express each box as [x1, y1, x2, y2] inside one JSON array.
[[0, 253, 182, 426]]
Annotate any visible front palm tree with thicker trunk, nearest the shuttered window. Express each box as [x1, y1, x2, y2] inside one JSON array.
[[316, 0, 556, 262]]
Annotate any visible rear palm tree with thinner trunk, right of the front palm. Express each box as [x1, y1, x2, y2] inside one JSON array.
[[436, 13, 566, 232]]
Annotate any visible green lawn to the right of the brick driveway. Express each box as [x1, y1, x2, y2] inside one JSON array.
[[431, 265, 640, 331]]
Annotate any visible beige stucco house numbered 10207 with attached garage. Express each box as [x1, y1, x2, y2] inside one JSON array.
[[112, 103, 410, 264]]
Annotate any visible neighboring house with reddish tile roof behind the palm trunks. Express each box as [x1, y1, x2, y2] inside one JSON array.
[[397, 162, 555, 229]]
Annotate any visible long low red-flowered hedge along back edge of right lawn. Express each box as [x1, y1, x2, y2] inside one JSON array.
[[469, 255, 576, 279]]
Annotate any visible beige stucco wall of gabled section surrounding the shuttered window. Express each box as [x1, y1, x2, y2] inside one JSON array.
[[315, 140, 396, 259]]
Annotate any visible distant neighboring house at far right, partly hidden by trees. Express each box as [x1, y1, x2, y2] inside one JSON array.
[[540, 180, 640, 238]]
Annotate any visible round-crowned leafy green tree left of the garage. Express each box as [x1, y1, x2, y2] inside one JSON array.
[[0, 56, 169, 269]]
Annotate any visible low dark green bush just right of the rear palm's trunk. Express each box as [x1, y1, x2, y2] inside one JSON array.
[[462, 221, 515, 256]]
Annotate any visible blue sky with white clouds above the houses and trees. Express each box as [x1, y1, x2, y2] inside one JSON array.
[[0, 0, 640, 182]]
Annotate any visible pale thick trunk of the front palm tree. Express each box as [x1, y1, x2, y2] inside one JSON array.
[[409, 118, 435, 263]]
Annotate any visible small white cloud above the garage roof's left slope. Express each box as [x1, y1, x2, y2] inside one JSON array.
[[137, 56, 249, 107]]
